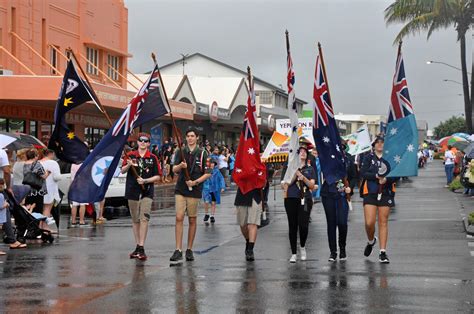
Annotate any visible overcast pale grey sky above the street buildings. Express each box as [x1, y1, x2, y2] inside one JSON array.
[[125, 0, 472, 129]]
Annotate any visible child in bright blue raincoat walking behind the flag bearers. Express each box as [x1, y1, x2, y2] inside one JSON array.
[[202, 159, 225, 225]]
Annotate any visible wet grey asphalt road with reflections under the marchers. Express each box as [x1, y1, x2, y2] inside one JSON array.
[[0, 163, 474, 313]]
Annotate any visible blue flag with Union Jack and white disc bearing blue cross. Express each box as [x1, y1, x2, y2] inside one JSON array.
[[68, 66, 170, 203]]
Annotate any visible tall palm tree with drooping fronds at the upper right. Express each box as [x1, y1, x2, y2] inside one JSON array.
[[385, 0, 474, 133]]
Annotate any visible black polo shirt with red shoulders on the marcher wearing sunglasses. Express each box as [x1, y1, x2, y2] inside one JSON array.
[[122, 150, 161, 201]]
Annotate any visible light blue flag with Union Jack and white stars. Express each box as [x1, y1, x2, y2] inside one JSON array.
[[383, 44, 418, 177]]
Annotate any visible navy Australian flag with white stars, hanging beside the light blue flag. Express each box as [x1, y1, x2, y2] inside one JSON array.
[[313, 55, 346, 184]]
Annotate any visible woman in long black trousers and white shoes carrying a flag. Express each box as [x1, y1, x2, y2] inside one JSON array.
[[283, 146, 317, 263]]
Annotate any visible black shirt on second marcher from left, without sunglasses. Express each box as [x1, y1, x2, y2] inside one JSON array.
[[173, 146, 211, 198]]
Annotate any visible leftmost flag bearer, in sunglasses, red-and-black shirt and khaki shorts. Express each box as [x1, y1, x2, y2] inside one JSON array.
[[122, 133, 161, 261]]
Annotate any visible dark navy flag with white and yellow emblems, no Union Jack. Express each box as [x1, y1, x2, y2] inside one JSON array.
[[48, 61, 96, 164]]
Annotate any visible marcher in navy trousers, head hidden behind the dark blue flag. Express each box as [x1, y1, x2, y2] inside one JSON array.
[[321, 161, 351, 262]]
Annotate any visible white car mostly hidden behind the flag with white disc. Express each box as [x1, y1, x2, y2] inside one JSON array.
[[58, 173, 127, 206]]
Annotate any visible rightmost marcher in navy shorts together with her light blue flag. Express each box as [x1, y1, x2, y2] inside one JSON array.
[[361, 42, 418, 264]]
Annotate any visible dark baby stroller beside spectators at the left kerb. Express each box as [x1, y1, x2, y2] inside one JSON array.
[[5, 186, 54, 243]]
